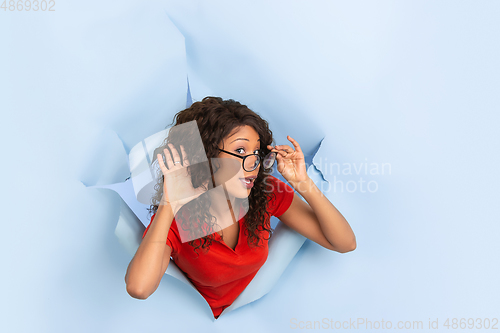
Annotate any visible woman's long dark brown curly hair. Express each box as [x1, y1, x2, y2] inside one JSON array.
[[148, 96, 274, 252]]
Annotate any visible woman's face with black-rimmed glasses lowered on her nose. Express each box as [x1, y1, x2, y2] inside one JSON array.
[[214, 125, 260, 198]]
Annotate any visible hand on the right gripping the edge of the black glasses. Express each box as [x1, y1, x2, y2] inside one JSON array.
[[267, 135, 309, 189]]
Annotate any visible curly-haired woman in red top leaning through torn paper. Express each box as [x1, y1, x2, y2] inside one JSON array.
[[125, 97, 356, 318]]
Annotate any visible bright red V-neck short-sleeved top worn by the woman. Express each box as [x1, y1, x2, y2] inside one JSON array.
[[142, 176, 294, 318]]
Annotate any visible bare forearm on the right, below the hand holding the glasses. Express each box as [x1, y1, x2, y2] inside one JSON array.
[[294, 178, 356, 251]]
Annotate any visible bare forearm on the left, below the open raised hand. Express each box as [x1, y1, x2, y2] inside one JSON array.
[[125, 205, 173, 298]]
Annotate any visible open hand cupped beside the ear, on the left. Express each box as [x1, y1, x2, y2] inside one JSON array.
[[157, 143, 205, 210]]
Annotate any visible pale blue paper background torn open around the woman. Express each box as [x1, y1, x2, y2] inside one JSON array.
[[0, 0, 500, 332]]
